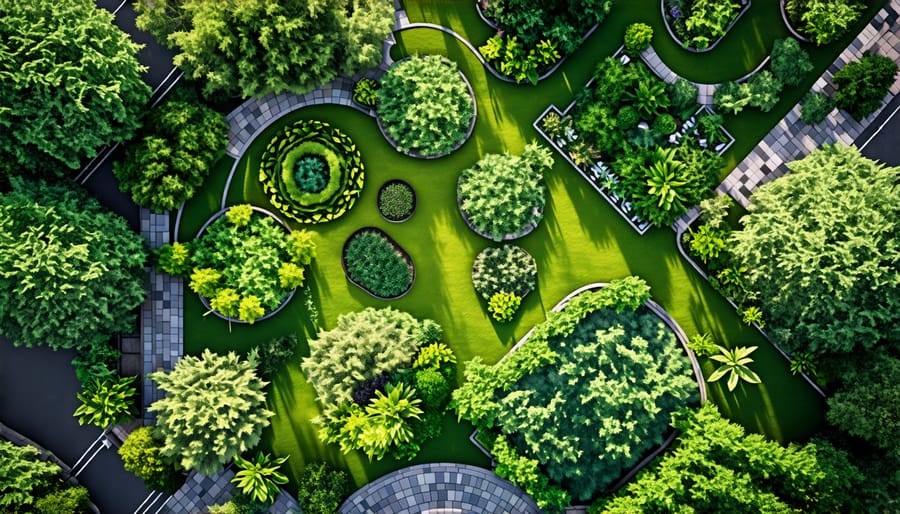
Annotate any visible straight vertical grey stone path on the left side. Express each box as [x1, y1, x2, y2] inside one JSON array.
[[141, 208, 184, 420]]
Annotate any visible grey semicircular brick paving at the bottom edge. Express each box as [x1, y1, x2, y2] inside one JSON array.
[[338, 463, 541, 514]]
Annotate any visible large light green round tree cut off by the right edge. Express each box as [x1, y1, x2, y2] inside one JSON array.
[[732, 145, 900, 354]]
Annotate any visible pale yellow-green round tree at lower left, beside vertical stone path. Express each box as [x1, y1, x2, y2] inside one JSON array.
[[148, 349, 273, 475]]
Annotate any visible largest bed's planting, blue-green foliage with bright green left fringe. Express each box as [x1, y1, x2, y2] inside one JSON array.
[[453, 277, 697, 504]]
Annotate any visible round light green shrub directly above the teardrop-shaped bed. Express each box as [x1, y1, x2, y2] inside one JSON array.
[[458, 143, 553, 241]]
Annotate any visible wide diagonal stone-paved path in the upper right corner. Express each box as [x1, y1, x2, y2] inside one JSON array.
[[717, 0, 900, 207]]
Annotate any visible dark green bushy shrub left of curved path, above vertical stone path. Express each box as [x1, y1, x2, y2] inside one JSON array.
[[113, 101, 228, 212]]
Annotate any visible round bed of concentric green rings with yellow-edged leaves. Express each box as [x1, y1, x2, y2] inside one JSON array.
[[259, 120, 365, 223]]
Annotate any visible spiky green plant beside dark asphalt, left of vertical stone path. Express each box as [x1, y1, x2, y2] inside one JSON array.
[[74, 377, 137, 428]]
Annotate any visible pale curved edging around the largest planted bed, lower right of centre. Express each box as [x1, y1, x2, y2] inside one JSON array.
[[469, 282, 708, 510]]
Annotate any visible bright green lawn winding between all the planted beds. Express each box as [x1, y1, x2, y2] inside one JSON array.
[[172, 0, 888, 492]]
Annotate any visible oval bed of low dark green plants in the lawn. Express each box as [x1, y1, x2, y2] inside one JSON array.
[[341, 227, 415, 300]]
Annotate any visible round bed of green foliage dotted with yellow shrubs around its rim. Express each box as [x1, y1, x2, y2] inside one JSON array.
[[189, 205, 316, 323]]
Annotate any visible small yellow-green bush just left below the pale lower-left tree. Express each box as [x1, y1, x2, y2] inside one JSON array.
[[119, 427, 183, 494]]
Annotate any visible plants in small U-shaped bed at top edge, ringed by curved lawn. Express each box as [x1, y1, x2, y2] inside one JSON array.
[[664, 0, 741, 50]]
